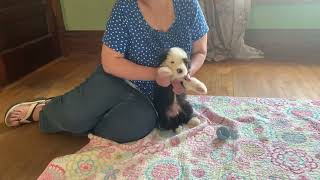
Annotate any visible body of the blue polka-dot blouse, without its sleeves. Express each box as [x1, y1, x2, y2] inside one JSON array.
[[104, 0, 204, 99]]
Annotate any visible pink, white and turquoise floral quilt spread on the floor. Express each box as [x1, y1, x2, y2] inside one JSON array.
[[39, 96, 320, 180]]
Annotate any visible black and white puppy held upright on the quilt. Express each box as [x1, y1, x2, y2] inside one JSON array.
[[154, 47, 198, 132]]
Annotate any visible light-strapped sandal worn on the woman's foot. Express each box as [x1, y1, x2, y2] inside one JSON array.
[[4, 98, 50, 127]]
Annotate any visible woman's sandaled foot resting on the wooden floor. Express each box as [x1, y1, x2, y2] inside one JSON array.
[[4, 99, 47, 127]]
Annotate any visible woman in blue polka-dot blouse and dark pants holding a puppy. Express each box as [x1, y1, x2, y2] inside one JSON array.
[[5, 0, 208, 143]]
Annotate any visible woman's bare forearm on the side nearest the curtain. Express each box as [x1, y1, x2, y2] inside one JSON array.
[[189, 34, 208, 76]]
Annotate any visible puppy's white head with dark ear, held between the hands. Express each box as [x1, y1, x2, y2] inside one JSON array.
[[161, 47, 190, 79]]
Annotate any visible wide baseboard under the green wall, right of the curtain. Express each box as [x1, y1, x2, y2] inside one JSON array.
[[245, 29, 320, 59]]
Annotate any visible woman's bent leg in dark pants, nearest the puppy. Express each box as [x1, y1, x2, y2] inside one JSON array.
[[94, 95, 157, 143]]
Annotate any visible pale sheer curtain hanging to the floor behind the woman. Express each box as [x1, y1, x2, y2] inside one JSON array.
[[199, 0, 263, 61]]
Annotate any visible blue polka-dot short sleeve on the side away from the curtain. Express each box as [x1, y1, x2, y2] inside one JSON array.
[[102, 0, 128, 54]]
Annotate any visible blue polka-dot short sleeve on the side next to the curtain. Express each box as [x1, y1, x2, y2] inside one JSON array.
[[191, 0, 209, 42]]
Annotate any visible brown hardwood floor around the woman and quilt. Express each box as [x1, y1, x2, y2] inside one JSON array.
[[0, 55, 320, 179]]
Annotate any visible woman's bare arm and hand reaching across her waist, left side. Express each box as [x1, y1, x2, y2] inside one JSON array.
[[101, 44, 171, 87]]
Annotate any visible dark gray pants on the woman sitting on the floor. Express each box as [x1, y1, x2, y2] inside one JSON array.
[[40, 65, 157, 143]]
